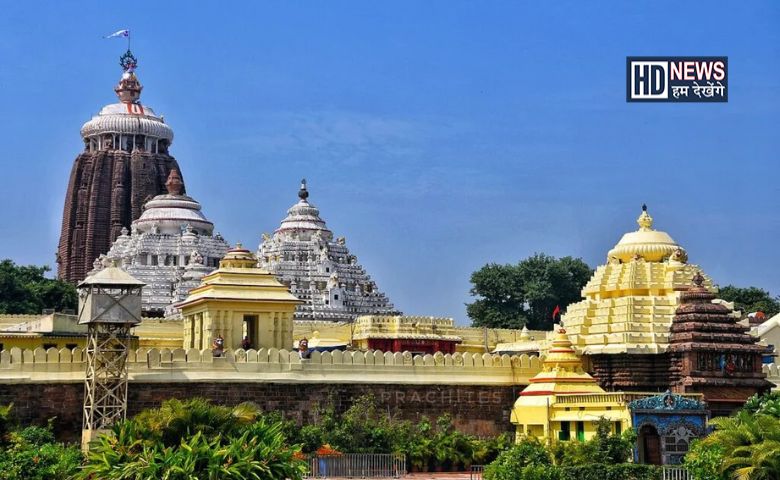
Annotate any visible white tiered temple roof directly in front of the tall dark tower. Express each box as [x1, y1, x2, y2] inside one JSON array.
[[95, 169, 230, 317]]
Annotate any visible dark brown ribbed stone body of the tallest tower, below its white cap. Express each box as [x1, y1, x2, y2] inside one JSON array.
[[57, 150, 181, 282]]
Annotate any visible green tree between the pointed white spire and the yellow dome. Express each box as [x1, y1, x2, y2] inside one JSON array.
[[466, 253, 593, 330]]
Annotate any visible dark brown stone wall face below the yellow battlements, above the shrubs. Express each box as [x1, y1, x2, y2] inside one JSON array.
[[0, 382, 523, 439]]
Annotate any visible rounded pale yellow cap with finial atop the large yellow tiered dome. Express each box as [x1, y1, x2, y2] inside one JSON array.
[[607, 205, 687, 262]]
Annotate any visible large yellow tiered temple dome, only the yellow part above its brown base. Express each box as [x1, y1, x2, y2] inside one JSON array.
[[562, 205, 715, 354]]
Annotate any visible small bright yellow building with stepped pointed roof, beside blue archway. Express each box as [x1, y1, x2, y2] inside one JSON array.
[[511, 328, 631, 441]]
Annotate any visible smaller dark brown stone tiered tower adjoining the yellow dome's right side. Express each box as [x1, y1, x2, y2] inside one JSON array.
[[669, 276, 772, 416]]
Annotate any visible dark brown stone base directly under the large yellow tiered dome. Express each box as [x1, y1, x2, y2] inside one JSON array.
[[587, 353, 670, 392]]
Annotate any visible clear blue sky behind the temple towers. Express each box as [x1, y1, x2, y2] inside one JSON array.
[[0, 0, 780, 323]]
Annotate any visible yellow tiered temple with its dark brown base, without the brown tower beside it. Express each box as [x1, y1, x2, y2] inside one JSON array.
[[562, 206, 714, 391]]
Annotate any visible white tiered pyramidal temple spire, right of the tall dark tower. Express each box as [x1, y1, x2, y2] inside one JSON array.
[[257, 180, 400, 322]]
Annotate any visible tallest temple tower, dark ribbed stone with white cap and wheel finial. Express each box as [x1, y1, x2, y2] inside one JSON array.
[[57, 50, 183, 282]]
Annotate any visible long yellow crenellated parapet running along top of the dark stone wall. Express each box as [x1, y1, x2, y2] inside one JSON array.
[[0, 348, 541, 386]]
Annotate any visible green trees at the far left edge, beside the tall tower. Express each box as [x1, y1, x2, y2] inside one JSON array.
[[0, 259, 78, 314]]
